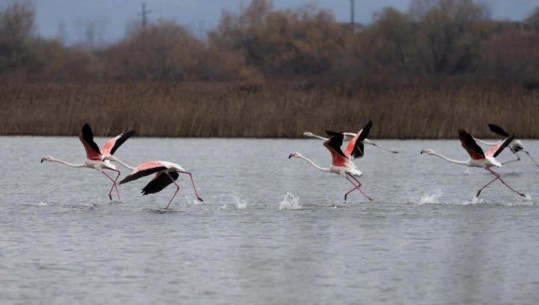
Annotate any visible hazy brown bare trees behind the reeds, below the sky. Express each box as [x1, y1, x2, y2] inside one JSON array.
[[0, 0, 539, 88]]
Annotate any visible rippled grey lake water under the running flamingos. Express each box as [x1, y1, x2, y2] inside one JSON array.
[[0, 137, 539, 304]]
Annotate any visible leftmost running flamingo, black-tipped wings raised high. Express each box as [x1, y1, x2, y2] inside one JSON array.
[[41, 124, 135, 201]]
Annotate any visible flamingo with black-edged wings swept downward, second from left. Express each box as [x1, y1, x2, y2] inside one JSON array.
[[120, 161, 204, 209]]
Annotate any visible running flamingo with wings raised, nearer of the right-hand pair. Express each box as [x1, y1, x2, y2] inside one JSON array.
[[421, 129, 526, 197]]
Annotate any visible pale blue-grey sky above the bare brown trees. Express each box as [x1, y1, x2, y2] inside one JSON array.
[[26, 0, 539, 43]]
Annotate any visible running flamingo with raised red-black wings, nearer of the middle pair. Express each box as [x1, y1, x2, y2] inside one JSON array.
[[288, 121, 373, 201]]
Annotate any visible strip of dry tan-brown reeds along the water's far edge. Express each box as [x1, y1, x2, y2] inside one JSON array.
[[0, 83, 539, 139]]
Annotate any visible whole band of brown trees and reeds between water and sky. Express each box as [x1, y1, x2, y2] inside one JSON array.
[[0, 0, 539, 138]]
